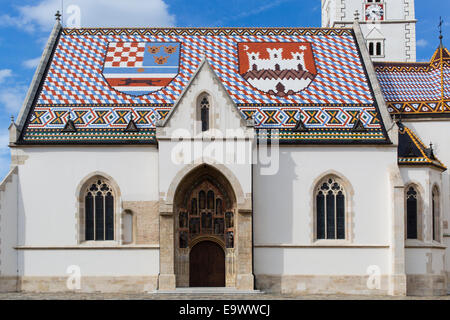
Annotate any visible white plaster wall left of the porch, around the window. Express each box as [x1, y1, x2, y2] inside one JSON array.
[[14, 146, 159, 276]]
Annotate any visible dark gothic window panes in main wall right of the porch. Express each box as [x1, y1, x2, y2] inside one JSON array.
[[315, 177, 346, 239]]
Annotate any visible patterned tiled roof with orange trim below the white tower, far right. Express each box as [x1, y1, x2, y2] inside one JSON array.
[[374, 46, 450, 116]]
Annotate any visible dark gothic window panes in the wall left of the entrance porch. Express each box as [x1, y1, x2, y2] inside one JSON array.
[[84, 179, 114, 241]]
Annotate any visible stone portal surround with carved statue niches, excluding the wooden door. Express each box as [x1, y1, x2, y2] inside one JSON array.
[[159, 164, 254, 290]]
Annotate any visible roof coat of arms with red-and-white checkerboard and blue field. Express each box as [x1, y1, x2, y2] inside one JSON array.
[[103, 42, 180, 96]]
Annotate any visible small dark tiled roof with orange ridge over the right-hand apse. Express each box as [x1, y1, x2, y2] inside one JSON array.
[[397, 122, 447, 170]]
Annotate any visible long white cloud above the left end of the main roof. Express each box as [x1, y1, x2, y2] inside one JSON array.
[[0, 0, 175, 31]]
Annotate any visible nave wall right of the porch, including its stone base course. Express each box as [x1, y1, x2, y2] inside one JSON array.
[[254, 146, 397, 294]]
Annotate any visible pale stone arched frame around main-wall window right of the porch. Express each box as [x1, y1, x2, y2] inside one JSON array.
[[311, 171, 354, 246]]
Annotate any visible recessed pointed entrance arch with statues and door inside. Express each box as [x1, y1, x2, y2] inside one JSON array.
[[174, 165, 237, 287]]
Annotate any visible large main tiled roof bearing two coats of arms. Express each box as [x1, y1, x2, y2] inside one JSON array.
[[20, 28, 387, 143]]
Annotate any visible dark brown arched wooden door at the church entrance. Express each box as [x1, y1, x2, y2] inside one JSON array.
[[189, 241, 225, 287]]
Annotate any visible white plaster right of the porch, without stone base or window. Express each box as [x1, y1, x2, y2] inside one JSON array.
[[253, 146, 397, 274]]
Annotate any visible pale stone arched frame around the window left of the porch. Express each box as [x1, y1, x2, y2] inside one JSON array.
[[76, 172, 123, 246]]
